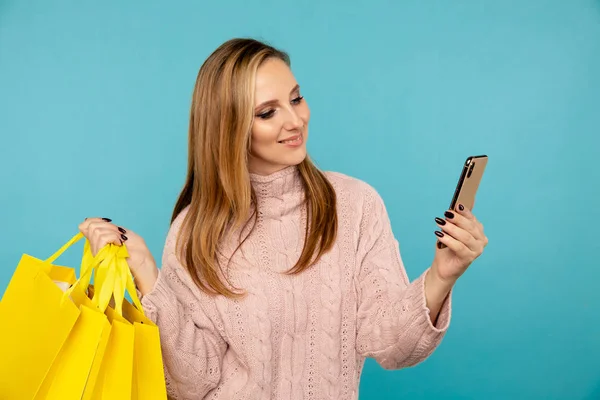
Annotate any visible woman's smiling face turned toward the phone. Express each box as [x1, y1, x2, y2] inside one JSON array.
[[248, 58, 310, 175]]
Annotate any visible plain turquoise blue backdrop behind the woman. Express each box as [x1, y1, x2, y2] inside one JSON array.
[[0, 0, 600, 399]]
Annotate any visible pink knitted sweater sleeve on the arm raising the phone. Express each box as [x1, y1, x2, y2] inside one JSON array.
[[355, 187, 451, 369]]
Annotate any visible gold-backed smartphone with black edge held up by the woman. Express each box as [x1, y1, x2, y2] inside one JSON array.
[[438, 155, 488, 249]]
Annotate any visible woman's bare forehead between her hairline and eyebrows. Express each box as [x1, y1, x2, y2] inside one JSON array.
[[255, 58, 297, 103]]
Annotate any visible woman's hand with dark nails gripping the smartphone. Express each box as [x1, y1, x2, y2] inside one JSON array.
[[431, 204, 488, 283]]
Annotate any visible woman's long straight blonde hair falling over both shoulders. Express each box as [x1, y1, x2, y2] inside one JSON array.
[[171, 39, 337, 298]]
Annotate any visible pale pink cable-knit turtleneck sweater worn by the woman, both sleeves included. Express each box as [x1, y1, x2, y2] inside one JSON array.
[[142, 167, 451, 400]]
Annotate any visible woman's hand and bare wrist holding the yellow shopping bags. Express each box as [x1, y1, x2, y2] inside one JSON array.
[[79, 218, 158, 296]]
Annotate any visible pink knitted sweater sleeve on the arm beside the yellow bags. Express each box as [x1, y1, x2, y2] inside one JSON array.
[[141, 212, 227, 399]]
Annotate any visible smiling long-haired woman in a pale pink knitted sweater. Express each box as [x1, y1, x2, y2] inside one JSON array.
[[80, 39, 487, 399]]
